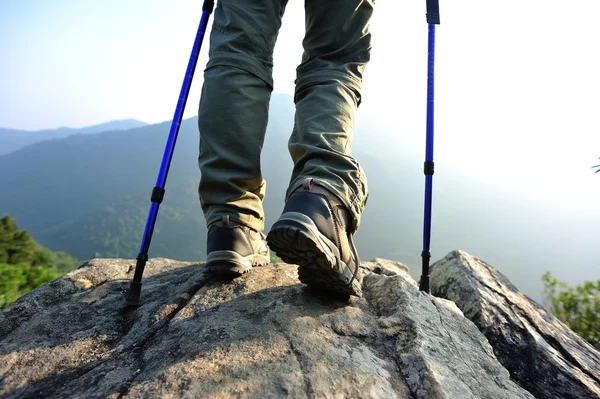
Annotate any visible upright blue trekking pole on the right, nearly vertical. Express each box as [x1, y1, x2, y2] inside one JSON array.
[[419, 0, 440, 294]]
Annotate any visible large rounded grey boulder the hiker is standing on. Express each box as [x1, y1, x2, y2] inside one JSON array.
[[0, 259, 532, 399]]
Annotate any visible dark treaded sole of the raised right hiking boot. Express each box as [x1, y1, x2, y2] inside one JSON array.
[[267, 212, 362, 296]]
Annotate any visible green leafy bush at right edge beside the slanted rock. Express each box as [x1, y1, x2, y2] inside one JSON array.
[[542, 272, 600, 349]]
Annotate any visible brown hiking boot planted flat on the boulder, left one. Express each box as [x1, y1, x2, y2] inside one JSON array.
[[205, 216, 270, 278]]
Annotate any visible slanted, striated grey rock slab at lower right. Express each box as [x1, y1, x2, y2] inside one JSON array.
[[431, 251, 600, 399]]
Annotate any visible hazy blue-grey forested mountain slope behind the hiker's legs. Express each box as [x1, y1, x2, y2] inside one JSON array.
[[0, 95, 600, 299]]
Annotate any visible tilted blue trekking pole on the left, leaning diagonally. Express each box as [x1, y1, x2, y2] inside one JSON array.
[[127, 0, 215, 306]]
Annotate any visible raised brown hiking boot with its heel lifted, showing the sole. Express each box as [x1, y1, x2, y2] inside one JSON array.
[[267, 179, 362, 296]]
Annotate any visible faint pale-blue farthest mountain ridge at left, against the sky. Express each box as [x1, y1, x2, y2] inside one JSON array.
[[0, 119, 148, 155]]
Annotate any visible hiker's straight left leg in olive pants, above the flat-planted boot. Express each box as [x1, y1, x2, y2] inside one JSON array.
[[198, 0, 287, 231]]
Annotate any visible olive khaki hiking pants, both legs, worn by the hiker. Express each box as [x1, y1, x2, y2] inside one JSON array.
[[198, 0, 375, 231]]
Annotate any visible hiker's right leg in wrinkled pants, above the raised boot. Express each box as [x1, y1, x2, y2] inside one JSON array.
[[286, 0, 374, 229]]
